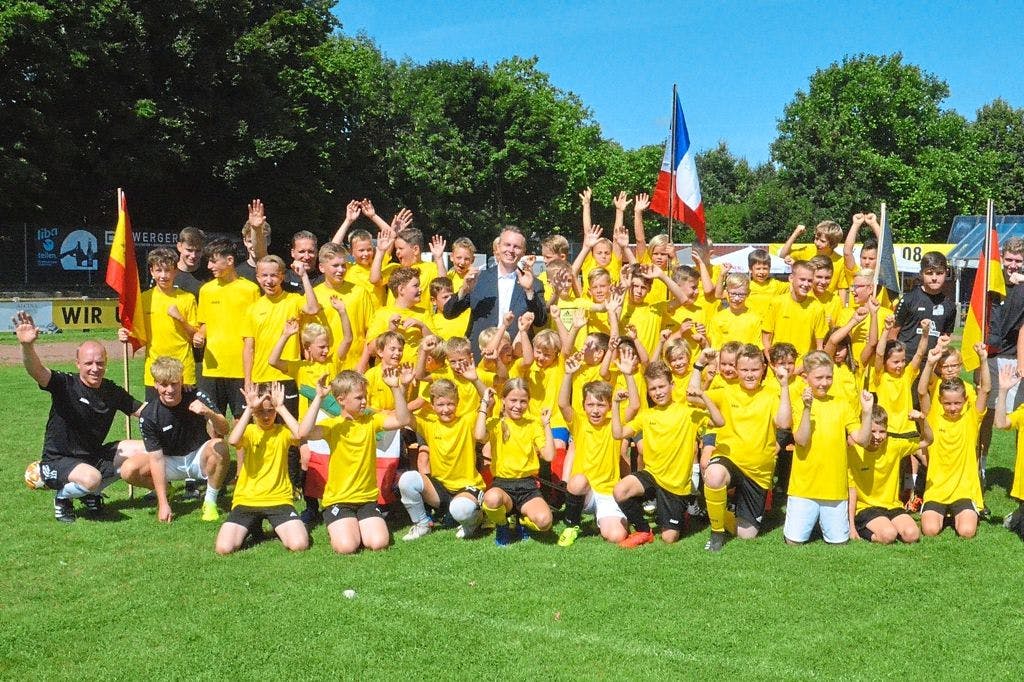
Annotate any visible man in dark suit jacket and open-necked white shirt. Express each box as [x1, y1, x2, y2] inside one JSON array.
[[443, 225, 548, 360]]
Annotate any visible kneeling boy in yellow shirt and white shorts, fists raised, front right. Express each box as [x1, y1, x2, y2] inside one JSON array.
[[782, 351, 873, 545]]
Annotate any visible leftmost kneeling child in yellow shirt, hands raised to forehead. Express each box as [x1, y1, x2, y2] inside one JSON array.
[[214, 383, 309, 554]]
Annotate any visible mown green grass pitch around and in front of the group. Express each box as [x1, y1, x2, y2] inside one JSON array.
[[0, 358, 1024, 680]]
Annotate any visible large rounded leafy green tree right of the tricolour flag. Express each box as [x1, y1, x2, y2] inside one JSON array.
[[772, 53, 992, 240]]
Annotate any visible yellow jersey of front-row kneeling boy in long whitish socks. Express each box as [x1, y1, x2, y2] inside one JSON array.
[[414, 410, 483, 493]]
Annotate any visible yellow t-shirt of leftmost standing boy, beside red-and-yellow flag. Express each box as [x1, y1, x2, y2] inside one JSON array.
[[141, 287, 197, 386]]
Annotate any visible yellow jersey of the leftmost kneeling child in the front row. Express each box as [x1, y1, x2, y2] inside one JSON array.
[[231, 424, 293, 509]]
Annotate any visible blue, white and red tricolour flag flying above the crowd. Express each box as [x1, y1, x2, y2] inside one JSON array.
[[650, 94, 708, 244]]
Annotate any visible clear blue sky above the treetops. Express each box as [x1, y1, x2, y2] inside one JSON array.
[[335, 0, 1024, 163]]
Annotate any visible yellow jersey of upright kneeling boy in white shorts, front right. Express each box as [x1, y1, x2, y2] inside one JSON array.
[[788, 395, 860, 501]]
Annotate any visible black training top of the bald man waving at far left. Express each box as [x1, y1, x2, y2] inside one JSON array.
[[41, 371, 142, 463]]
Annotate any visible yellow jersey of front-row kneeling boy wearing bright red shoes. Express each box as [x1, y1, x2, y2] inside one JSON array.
[[627, 402, 708, 495]]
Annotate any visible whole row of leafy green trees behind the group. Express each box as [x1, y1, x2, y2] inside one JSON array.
[[0, 0, 1024, 243]]
